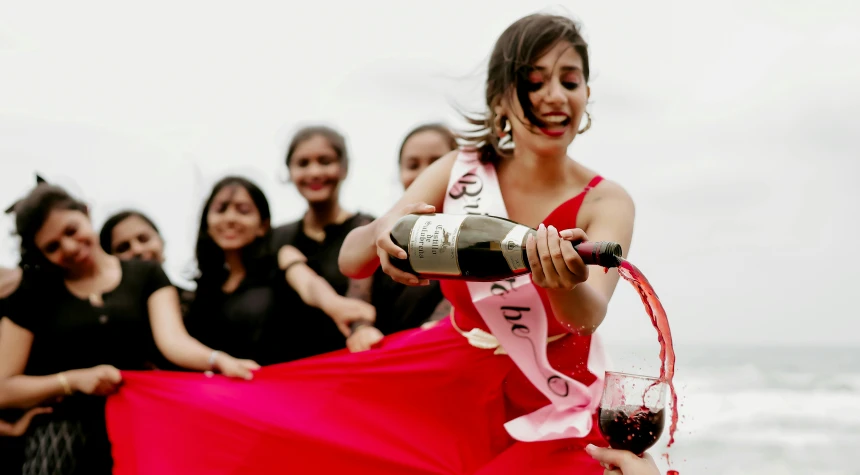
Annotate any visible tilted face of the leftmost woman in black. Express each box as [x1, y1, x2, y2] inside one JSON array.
[[34, 209, 98, 272]]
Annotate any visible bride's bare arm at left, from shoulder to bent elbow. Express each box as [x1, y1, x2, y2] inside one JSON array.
[[337, 150, 460, 279]]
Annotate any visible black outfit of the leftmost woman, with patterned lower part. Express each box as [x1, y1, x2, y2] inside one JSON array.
[[7, 260, 171, 475]]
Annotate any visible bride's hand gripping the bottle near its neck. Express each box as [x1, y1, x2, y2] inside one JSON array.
[[526, 224, 588, 291]]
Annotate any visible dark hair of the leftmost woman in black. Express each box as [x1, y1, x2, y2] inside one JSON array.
[[7, 180, 88, 275]]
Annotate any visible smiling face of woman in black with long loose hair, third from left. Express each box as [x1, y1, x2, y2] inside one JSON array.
[[206, 185, 268, 251]]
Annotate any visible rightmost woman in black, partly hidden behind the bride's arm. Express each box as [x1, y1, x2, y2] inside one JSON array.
[[356, 123, 457, 338]]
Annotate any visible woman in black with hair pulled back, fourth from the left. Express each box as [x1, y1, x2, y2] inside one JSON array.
[[272, 126, 382, 356]]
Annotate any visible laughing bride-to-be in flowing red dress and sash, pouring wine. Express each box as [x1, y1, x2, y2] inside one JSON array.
[[108, 15, 634, 475]]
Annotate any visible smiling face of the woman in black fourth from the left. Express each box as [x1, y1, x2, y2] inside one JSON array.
[[289, 135, 346, 203]]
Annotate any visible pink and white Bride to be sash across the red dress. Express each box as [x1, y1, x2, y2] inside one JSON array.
[[444, 152, 605, 442]]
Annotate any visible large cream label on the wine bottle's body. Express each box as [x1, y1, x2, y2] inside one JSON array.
[[409, 214, 468, 275]]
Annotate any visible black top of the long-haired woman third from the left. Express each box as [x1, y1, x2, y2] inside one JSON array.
[[185, 256, 301, 365]]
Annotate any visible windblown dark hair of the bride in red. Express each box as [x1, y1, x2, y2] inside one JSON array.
[[463, 13, 589, 163]]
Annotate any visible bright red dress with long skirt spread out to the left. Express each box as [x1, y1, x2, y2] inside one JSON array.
[[107, 177, 606, 475]]
